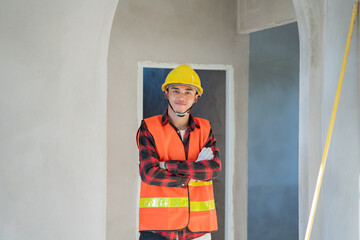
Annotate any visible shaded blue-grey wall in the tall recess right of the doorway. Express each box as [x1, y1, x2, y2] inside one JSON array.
[[248, 23, 299, 240]]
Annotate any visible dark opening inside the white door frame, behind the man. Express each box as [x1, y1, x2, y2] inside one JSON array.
[[143, 68, 226, 240]]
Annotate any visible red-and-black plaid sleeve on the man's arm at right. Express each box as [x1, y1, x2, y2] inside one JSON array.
[[166, 129, 221, 181]]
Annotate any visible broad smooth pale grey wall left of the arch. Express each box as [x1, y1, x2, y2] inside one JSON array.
[[0, 0, 117, 240]]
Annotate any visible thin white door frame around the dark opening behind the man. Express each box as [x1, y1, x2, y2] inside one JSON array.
[[135, 61, 235, 240]]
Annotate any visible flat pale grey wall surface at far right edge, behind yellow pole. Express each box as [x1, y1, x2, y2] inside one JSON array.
[[320, 0, 360, 240]]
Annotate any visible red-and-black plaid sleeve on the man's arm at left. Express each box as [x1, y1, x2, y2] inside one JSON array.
[[136, 121, 190, 187]]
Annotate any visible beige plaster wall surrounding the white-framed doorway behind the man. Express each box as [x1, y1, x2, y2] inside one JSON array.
[[107, 0, 248, 240]]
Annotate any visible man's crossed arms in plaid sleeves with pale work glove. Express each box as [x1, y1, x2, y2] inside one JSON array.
[[137, 121, 221, 187]]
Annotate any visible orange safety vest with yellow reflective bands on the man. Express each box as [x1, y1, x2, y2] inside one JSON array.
[[139, 115, 218, 232]]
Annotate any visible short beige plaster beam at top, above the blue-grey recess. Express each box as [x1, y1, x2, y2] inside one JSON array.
[[237, 0, 296, 33]]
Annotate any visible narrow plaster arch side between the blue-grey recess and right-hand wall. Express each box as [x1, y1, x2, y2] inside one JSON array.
[[293, 0, 324, 239]]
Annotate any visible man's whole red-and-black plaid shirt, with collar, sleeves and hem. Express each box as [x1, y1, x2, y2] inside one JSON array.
[[137, 111, 221, 240]]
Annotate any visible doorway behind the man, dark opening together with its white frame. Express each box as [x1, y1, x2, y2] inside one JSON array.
[[138, 63, 234, 240]]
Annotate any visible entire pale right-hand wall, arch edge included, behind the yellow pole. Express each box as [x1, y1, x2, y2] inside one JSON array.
[[294, 0, 360, 239]]
